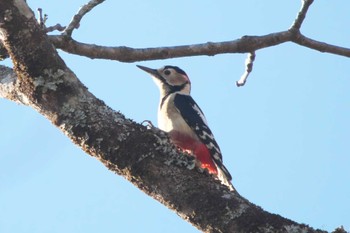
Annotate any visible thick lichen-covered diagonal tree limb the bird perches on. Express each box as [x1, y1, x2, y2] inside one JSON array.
[[0, 0, 328, 232]]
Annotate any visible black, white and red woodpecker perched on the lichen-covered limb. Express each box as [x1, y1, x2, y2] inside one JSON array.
[[137, 65, 233, 190]]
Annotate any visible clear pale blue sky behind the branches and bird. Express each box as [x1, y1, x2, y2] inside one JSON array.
[[0, 0, 350, 233]]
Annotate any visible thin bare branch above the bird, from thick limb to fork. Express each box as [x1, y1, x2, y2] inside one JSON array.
[[50, 31, 292, 62]]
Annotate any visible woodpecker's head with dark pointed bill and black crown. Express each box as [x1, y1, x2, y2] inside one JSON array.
[[137, 65, 191, 96]]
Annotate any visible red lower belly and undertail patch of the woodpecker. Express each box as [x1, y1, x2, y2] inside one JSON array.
[[169, 131, 218, 175]]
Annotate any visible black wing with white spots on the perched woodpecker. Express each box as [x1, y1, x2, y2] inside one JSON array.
[[174, 94, 231, 180]]
